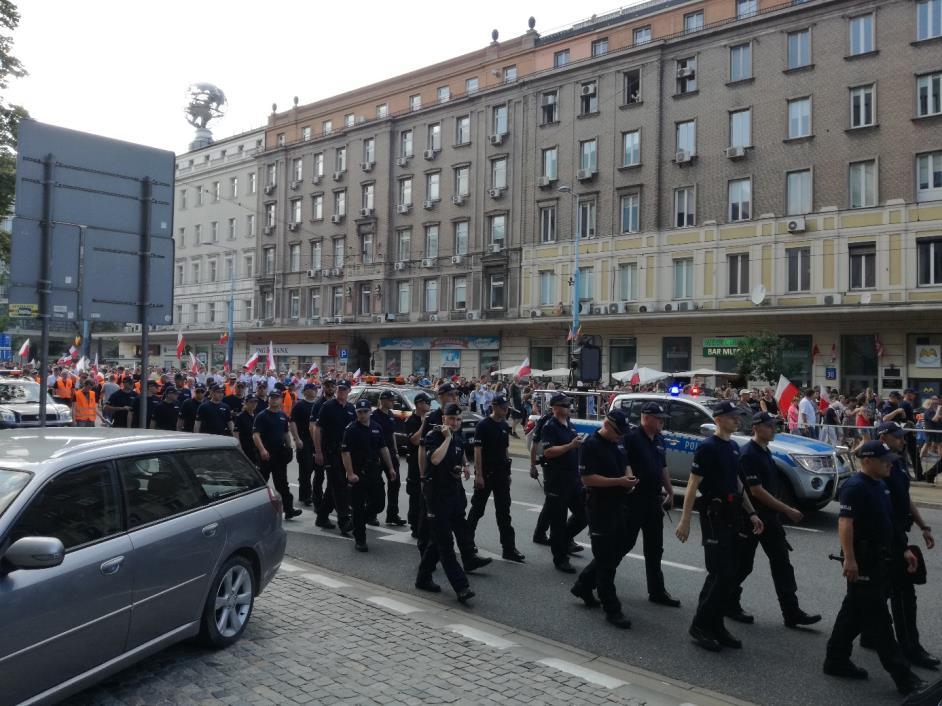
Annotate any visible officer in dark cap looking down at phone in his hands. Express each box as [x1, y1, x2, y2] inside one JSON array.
[[570, 409, 638, 630]]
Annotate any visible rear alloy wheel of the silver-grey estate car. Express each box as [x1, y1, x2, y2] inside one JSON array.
[[200, 556, 255, 647]]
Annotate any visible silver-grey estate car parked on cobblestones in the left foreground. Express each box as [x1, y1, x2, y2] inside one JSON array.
[[0, 428, 286, 704]]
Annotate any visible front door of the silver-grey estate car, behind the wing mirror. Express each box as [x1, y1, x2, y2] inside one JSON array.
[[0, 461, 135, 704]]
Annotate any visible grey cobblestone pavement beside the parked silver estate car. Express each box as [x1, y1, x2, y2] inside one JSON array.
[[65, 560, 744, 706]]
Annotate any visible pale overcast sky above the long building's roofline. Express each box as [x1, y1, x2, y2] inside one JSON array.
[[7, 0, 635, 153]]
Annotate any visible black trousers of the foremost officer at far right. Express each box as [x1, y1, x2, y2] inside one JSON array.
[[827, 576, 910, 678]]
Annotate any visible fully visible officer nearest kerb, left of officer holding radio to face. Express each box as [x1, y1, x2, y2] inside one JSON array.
[[340, 397, 396, 552]]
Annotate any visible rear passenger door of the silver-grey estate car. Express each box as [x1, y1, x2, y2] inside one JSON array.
[[116, 452, 226, 649]]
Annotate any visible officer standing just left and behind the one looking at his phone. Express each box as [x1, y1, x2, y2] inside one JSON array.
[[540, 394, 586, 574]]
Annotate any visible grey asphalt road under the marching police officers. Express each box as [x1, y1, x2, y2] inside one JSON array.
[[287, 458, 942, 706]]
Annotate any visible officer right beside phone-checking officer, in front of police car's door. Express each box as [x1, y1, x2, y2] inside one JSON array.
[[625, 402, 680, 608]]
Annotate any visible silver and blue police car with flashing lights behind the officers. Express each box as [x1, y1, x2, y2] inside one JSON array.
[[528, 392, 853, 510]]
